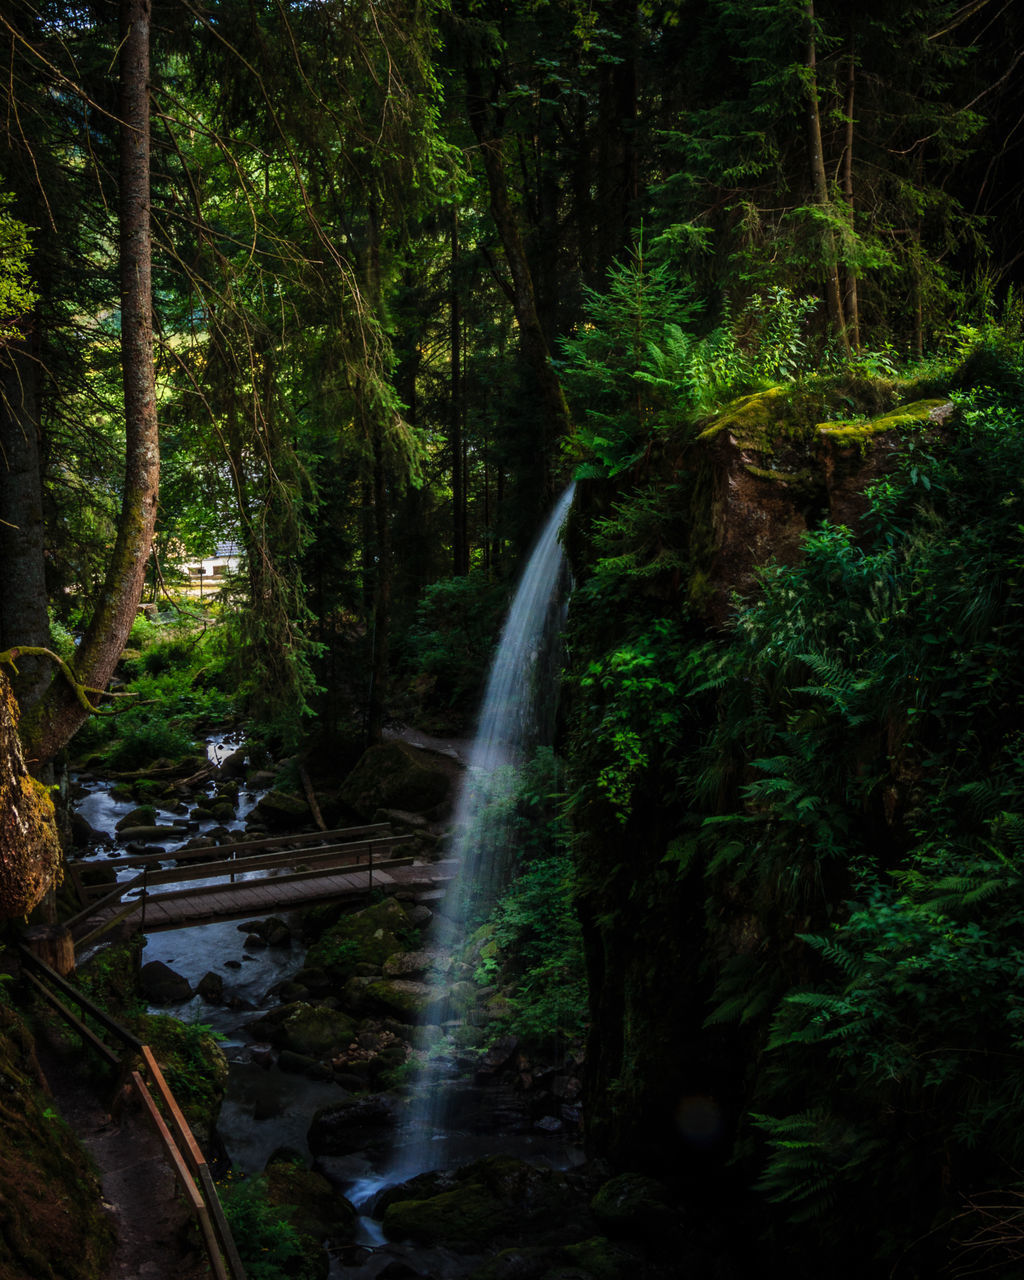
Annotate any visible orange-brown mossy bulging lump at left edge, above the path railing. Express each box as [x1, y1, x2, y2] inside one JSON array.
[[0, 671, 61, 919]]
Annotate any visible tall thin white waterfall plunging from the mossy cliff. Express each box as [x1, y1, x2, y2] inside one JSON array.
[[348, 485, 575, 1204]]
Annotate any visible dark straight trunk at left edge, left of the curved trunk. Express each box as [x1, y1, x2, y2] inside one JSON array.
[[0, 338, 52, 713]]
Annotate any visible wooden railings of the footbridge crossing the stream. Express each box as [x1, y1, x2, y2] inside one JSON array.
[[63, 823, 416, 948]]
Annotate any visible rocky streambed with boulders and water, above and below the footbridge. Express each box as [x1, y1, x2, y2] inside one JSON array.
[[64, 741, 706, 1280]]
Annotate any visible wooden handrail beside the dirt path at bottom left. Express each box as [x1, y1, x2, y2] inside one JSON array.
[[19, 946, 246, 1280]]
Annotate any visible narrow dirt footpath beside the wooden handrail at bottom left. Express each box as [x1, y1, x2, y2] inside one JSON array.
[[36, 1034, 209, 1280]]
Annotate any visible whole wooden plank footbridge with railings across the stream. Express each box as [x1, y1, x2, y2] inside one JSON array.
[[64, 823, 454, 951]]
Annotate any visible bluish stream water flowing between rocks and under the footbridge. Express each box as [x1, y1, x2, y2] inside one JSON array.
[[73, 735, 582, 1280]]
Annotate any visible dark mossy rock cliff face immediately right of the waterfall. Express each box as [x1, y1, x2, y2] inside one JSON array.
[[566, 381, 951, 1183]]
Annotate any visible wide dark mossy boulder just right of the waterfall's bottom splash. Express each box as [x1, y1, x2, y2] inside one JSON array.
[[383, 1156, 575, 1249]]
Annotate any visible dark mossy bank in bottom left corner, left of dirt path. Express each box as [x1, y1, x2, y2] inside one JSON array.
[[0, 1005, 114, 1280]]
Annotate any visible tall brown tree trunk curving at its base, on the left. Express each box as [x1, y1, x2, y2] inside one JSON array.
[[23, 0, 160, 769]]
